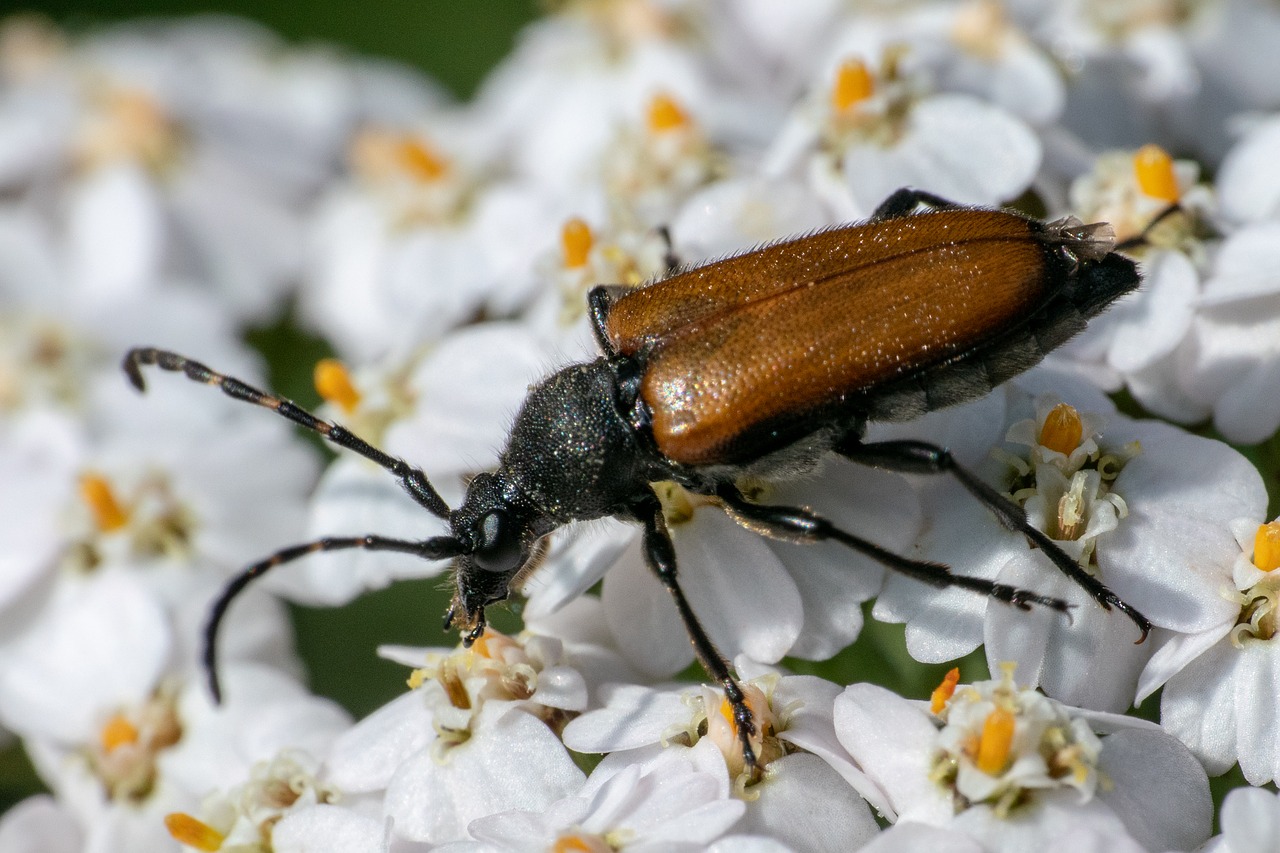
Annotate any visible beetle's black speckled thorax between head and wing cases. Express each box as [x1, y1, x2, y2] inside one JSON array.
[[502, 359, 650, 524]]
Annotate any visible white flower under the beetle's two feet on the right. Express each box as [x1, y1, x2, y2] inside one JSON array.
[[874, 386, 1266, 711]]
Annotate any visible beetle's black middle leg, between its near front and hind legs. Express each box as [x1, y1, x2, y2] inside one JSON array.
[[716, 483, 1071, 613]]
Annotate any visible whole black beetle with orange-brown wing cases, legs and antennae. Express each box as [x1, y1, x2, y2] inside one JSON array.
[[123, 188, 1151, 767]]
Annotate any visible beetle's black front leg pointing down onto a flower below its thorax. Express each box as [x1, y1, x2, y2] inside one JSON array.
[[631, 492, 756, 774]]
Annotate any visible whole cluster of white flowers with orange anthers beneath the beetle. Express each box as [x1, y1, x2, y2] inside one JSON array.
[[0, 0, 1280, 853]]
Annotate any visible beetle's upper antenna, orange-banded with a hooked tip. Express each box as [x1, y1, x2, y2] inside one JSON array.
[[122, 347, 449, 520]]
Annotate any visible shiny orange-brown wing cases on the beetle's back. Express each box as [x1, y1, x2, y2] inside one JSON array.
[[607, 210, 1121, 465]]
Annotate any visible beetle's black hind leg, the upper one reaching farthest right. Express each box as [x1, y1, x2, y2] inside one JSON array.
[[836, 438, 1151, 643]]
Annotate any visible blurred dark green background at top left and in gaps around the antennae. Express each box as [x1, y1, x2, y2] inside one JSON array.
[[0, 0, 540, 813]]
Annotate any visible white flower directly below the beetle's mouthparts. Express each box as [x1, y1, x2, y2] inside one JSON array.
[[326, 629, 588, 843]]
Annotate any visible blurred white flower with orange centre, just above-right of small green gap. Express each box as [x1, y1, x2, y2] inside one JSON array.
[[300, 128, 547, 360]]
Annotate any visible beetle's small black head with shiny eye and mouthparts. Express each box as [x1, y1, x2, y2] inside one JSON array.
[[444, 474, 541, 646]]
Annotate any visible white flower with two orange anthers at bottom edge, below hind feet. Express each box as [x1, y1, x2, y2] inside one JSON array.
[[835, 666, 1212, 850]]
